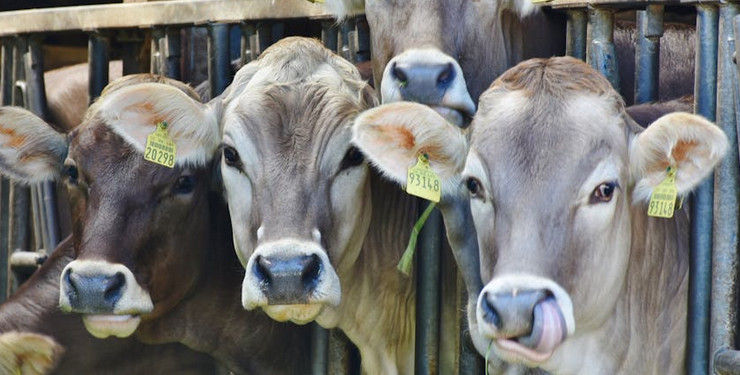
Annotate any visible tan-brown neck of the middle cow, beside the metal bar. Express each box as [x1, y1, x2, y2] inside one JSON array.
[[319, 171, 420, 374]]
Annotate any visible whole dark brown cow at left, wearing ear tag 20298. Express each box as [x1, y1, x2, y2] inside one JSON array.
[[0, 75, 310, 374]]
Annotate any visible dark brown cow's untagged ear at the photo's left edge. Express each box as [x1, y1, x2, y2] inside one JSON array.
[[0, 107, 68, 184]]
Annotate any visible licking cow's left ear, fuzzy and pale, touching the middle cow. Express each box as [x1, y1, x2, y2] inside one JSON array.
[[352, 102, 468, 189]]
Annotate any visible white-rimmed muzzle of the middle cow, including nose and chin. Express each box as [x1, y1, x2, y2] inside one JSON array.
[[242, 240, 341, 324]]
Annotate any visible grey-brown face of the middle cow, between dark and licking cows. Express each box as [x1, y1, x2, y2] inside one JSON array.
[[215, 38, 372, 323]]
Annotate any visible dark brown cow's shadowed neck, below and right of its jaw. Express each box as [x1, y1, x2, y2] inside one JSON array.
[[137, 193, 310, 375]]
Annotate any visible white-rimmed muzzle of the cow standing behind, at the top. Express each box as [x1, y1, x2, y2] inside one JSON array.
[[380, 49, 475, 128]]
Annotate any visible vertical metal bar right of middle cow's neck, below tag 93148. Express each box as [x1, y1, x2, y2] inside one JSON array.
[[414, 204, 442, 375]]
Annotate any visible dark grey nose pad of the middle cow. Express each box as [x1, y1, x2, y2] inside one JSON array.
[[252, 254, 324, 305]]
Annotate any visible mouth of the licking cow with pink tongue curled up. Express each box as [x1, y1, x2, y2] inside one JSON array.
[[495, 297, 568, 363]]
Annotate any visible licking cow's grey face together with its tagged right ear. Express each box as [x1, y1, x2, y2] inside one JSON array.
[[464, 58, 727, 373]]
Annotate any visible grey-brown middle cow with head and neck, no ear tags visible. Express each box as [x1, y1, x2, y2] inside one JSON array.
[[220, 38, 454, 375]]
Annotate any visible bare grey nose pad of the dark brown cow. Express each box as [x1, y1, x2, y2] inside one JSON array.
[[63, 268, 126, 313]]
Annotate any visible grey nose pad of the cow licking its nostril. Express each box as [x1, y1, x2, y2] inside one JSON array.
[[481, 289, 552, 338]]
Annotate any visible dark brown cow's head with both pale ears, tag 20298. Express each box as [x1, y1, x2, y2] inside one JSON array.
[[0, 75, 219, 337]]
